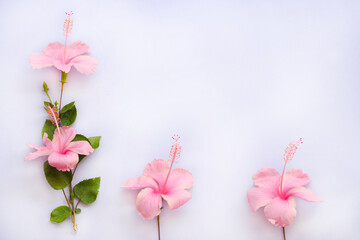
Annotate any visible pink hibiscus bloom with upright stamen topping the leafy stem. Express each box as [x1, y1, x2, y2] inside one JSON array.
[[29, 12, 98, 74]]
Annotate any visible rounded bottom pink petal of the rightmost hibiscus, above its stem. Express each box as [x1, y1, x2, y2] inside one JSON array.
[[264, 197, 296, 227]]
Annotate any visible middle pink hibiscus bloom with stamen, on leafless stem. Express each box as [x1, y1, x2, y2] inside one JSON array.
[[122, 135, 193, 219]]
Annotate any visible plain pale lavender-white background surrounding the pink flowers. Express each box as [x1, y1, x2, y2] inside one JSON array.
[[0, 0, 360, 240]]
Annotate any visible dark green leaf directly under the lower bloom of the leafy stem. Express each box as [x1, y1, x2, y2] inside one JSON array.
[[44, 161, 72, 190]]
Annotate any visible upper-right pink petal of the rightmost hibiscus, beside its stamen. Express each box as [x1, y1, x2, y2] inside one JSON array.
[[283, 169, 311, 193]]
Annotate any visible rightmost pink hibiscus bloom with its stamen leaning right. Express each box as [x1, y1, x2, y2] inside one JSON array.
[[247, 139, 322, 227]]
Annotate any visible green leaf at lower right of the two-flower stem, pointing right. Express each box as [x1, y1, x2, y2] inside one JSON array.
[[74, 177, 100, 204]]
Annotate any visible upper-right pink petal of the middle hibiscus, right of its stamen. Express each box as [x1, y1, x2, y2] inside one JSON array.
[[165, 168, 194, 191]]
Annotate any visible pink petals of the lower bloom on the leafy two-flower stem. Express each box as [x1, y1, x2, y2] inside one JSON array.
[[25, 126, 94, 171]]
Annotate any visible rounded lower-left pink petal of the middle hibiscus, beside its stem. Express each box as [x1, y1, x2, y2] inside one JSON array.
[[136, 188, 162, 219]]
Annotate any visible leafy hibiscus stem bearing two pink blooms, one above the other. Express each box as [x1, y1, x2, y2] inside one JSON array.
[[25, 12, 100, 231]]
